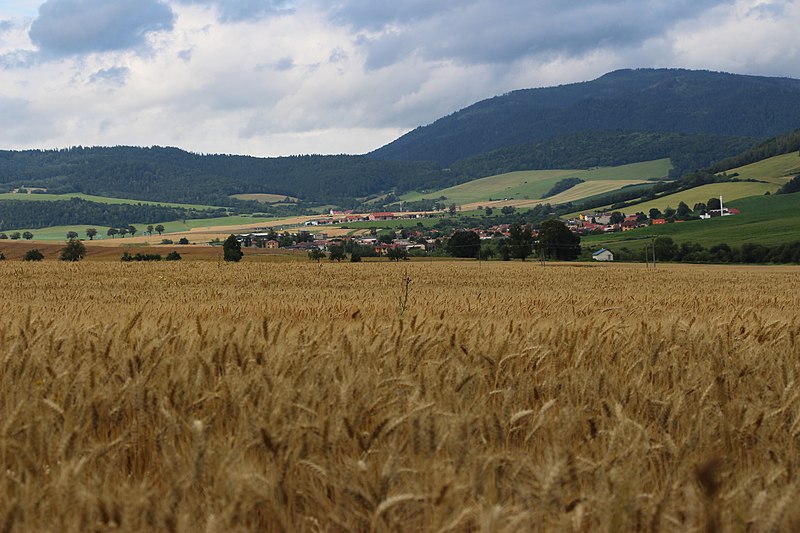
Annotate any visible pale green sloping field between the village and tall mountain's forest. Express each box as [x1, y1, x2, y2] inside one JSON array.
[[400, 159, 671, 204]]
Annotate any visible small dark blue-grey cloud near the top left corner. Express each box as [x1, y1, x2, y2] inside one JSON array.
[[30, 0, 175, 57]]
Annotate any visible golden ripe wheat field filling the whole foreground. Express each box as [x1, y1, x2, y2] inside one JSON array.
[[0, 261, 800, 532]]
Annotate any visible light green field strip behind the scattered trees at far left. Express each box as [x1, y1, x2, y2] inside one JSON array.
[[0, 216, 279, 243]]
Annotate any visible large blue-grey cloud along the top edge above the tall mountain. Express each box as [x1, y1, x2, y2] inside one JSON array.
[[332, 0, 725, 69]]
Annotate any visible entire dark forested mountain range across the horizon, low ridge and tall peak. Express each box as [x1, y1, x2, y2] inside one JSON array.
[[0, 69, 800, 206]]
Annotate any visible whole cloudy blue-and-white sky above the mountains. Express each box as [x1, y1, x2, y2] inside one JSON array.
[[0, 0, 800, 156]]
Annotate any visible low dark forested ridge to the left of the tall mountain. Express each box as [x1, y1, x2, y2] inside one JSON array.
[[0, 146, 445, 206]]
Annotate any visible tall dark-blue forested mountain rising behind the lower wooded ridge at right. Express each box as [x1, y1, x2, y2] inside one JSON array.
[[369, 69, 800, 166]]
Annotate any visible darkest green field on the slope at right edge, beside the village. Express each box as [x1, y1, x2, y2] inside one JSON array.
[[581, 193, 800, 250]]
